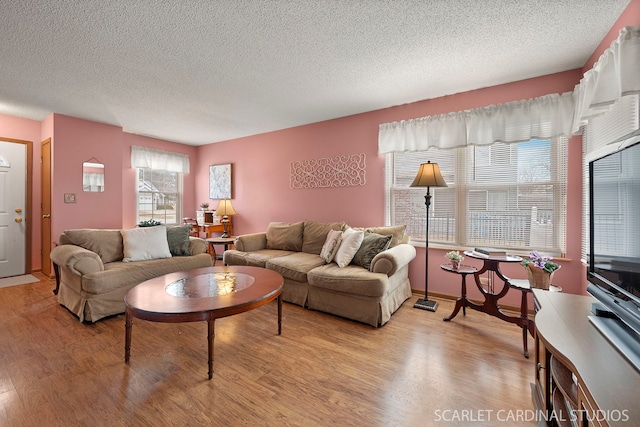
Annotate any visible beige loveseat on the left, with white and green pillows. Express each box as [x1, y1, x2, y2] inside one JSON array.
[[51, 226, 212, 322]]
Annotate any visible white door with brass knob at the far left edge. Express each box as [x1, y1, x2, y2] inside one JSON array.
[[0, 141, 27, 277]]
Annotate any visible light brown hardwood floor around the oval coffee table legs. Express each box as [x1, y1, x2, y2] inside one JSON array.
[[0, 276, 535, 426]]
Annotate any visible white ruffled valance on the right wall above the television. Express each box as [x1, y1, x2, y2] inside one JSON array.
[[573, 26, 640, 133]]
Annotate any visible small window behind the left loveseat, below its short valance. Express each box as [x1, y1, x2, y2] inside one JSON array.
[[137, 168, 182, 224]]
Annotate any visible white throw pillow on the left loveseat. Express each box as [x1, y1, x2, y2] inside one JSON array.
[[120, 225, 171, 262]]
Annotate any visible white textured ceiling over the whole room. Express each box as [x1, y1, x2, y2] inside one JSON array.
[[0, 0, 629, 145]]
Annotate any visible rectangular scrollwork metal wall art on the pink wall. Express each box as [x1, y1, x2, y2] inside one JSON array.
[[290, 153, 366, 188]]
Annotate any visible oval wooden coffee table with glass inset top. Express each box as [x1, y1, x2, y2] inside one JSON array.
[[124, 266, 284, 379]]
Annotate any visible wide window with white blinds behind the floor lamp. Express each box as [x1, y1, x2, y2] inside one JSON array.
[[386, 137, 567, 254]]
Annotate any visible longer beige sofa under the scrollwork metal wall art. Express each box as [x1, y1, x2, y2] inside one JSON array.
[[224, 220, 416, 327]]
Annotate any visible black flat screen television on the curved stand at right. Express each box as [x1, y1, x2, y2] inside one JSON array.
[[587, 137, 640, 371]]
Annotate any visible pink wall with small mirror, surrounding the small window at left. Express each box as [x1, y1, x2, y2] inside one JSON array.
[[52, 114, 196, 239]]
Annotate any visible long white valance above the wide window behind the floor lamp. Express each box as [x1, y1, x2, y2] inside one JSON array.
[[378, 92, 574, 154]]
